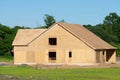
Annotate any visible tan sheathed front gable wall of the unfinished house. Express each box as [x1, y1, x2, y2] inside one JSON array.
[[14, 25, 96, 64]]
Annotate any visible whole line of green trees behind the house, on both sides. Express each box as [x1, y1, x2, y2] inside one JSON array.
[[0, 13, 120, 56]]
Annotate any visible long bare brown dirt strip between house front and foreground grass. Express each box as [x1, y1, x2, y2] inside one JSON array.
[[36, 63, 120, 69]]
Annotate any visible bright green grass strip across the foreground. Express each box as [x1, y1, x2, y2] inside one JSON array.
[[0, 66, 120, 80]]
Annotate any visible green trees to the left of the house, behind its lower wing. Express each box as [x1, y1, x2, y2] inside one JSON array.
[[0, 24, 29, 55]]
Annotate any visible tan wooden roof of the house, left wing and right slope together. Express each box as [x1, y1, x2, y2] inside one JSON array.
[[13, 23, 116, 50]]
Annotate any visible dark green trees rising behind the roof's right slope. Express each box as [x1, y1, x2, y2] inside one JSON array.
[[84, 13, 120, 56]]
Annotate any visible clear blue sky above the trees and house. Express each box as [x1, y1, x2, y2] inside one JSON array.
[[0, 0, 120, 28]]
